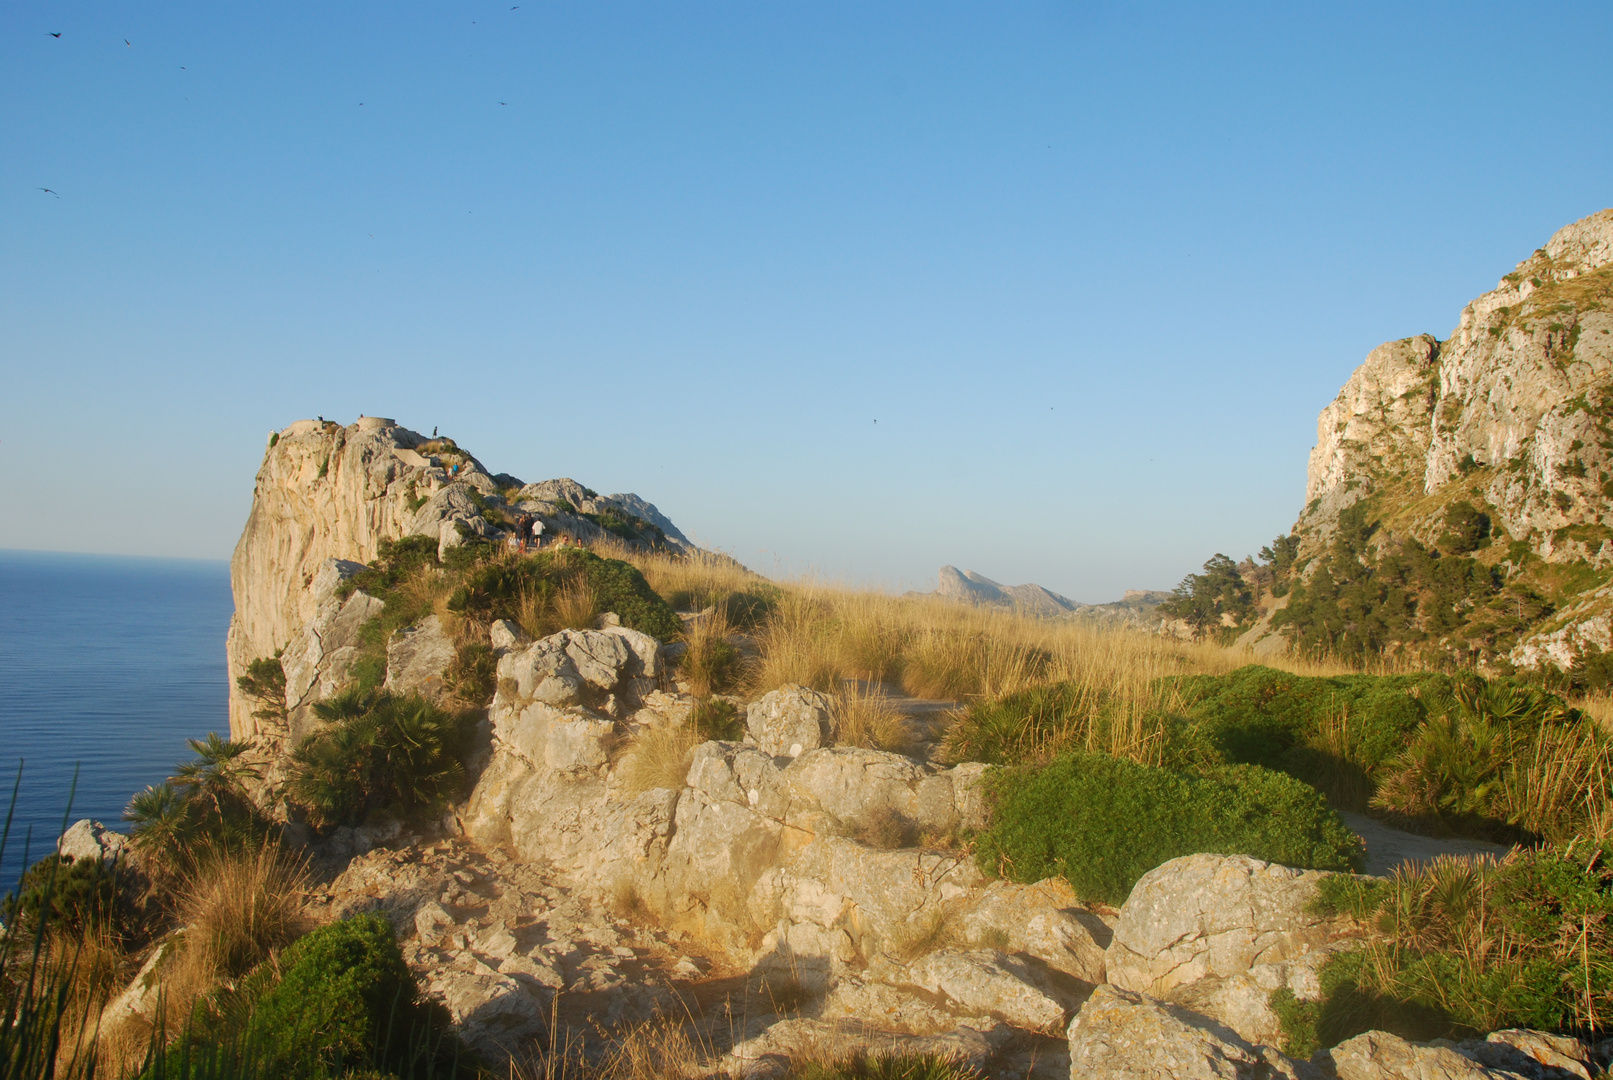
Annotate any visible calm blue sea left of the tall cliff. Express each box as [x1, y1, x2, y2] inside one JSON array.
[[0, 551, 232, 891]]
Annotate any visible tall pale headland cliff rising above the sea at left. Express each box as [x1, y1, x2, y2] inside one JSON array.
[[226, 416, 690, 738]]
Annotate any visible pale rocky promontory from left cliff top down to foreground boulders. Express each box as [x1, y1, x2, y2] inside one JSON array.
[[141, 417, 1597, 1080]]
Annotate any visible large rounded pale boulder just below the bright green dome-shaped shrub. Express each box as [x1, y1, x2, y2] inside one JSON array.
[[1105, 854, 1355, 996]]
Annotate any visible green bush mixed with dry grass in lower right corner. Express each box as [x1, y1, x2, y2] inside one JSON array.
[[1273, 841, 1613, 1048]]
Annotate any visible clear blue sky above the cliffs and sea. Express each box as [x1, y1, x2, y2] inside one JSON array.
[[0, 0, 1613, 601]]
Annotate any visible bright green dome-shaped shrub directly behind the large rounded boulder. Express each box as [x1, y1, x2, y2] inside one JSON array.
[[977, 754, 1361, 904]]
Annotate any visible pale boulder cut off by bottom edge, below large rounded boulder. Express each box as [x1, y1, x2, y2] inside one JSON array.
[[1068, 987, 1321, 1080]]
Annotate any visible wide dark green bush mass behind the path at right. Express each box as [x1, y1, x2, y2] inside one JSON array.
[[1154, 666, 1613, 843]]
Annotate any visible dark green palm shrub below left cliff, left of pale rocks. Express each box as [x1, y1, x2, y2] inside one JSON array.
[[287, 688, 471, 829]]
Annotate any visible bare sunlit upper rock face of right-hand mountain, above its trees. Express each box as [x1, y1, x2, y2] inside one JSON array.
[[1300, 210, 1613, 566]]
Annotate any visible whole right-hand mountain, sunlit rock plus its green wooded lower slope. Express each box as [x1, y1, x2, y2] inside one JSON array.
[[1245, 210, 1613, 667]]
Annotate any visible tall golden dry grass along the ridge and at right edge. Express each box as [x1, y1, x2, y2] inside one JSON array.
[[602, 546, 1613, 838]]
